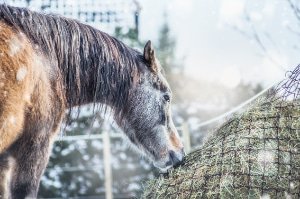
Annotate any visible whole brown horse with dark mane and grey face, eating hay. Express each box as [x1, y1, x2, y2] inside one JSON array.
[[0, 5, 183, 199]]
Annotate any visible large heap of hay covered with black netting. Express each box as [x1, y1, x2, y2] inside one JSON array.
[[143, 66, 300, 199]]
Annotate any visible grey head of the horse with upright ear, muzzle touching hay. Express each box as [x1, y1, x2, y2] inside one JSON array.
[[120, 41, 184, 171]]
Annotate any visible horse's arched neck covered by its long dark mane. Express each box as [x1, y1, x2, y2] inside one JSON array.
[[0, 4, 143, 116]]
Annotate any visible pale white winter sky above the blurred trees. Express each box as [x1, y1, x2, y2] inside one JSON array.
[[139, 0, 300, 88]]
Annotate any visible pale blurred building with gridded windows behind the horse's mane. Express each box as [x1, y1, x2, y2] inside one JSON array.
[[0, 0, 141, 34]]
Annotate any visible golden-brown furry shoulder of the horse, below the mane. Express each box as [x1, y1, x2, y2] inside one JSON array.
[[0, 21, 62, 153]]
